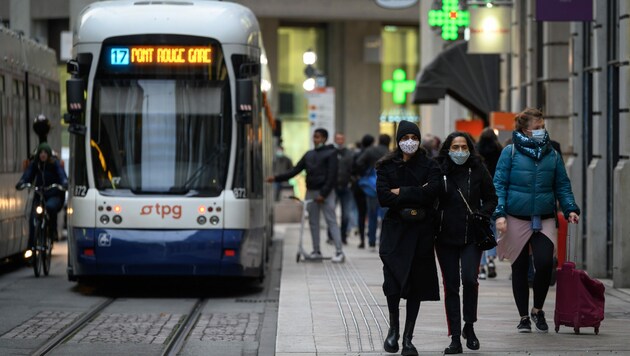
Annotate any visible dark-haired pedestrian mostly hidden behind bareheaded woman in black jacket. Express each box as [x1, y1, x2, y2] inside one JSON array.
[[476, 127, 503, 279]]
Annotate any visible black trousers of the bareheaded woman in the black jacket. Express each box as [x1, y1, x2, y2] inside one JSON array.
[[435, 244, 482, 336]]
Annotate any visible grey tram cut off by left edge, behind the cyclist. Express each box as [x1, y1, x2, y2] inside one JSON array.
[[0, 25, 61, 262]]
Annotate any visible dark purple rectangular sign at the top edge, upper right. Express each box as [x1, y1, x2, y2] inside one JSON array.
[[536, 0, 593, 21]]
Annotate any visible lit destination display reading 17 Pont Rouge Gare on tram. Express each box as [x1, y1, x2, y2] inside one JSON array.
[[106, 46, 212, 66]]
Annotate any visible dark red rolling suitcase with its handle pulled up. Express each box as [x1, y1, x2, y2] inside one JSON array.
[[553, 224, 605, 334]]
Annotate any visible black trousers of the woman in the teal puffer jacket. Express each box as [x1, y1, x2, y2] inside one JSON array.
[[512, 232, 553, 316]]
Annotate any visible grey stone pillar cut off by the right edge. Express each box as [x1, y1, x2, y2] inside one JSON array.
[[612, 0, 630, 288]]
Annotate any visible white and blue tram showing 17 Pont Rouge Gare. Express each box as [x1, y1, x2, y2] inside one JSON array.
[[67, 0, 273, 280]]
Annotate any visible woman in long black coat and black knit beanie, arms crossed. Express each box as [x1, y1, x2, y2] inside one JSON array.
[[376, 121, 440, 355]]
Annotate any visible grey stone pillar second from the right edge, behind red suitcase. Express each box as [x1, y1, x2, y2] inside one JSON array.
[[586, 1, 608, 278]]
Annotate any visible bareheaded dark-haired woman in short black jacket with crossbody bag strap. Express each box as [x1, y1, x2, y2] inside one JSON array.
[[435, 132, 497, 354]]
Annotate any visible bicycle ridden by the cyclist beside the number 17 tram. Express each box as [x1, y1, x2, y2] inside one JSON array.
[[20, 183, 65, 277]]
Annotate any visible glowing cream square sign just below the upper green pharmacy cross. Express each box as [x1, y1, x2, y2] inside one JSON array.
[[468, 7, 511, 54]]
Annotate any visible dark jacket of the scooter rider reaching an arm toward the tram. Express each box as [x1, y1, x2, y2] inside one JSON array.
[[274, 145, 337, 198]]
